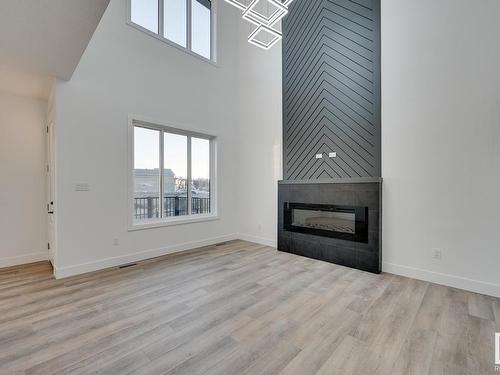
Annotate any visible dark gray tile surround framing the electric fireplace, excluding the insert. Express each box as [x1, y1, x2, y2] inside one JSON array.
[[278, 177, 382, 273]]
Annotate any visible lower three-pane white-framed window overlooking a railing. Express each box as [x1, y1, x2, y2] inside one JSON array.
[[132, 121, 215, 224]]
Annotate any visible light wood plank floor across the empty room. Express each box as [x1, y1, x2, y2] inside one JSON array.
[[0, 241, 500, 375]]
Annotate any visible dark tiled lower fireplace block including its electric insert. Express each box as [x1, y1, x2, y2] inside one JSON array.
[[278, 177, 382, 273]]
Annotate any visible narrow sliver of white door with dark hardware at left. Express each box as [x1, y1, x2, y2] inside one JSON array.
[[46, 123, 56, 264]]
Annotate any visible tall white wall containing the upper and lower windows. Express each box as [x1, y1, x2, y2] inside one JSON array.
[[52, 0, 240, 276]]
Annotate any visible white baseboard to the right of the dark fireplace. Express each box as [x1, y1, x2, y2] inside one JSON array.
[[382, 262, 500, 298]]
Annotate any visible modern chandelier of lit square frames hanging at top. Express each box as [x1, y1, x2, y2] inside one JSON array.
[[225, 0, 293, 50]]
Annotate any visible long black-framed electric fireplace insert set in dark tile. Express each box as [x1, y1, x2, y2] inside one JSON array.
[[283, 202, 368, 243]]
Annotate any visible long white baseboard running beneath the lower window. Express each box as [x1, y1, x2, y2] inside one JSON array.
[[54, 234, 239, 279]]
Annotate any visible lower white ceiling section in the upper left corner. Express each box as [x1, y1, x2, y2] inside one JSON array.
[[0, 0, 109, 98]]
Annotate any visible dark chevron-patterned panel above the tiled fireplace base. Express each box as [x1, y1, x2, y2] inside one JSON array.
[[283, 0, 381, 180]]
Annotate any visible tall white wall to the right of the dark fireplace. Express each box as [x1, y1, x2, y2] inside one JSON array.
[[382, 0, 500, 296]]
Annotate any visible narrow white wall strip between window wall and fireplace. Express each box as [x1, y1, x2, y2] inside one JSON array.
[[238, 20, 282, 250]]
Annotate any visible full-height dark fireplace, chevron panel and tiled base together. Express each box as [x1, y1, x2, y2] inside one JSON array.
[[276, 0, 382, 273]]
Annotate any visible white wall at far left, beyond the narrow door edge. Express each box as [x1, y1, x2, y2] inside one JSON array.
[[0, 93, 48, 267]]
